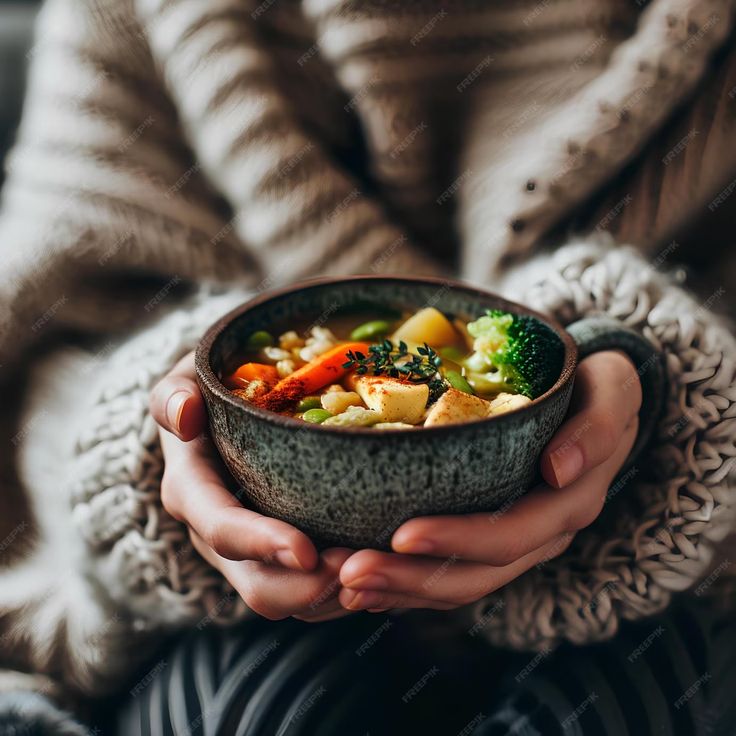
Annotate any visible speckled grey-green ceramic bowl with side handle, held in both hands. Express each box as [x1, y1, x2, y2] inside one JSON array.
[[196, 276, 653, 548]]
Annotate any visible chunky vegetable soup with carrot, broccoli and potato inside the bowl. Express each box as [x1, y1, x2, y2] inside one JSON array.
[[221, 306, 564, 430]]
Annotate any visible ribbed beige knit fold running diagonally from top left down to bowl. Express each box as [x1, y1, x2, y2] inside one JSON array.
[[135, 0, 438, 285]]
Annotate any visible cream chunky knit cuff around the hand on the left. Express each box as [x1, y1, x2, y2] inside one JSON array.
[[70, 291, 256, 631]]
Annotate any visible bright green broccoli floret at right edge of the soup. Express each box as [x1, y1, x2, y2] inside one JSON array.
[[465, 309, 565, 399]]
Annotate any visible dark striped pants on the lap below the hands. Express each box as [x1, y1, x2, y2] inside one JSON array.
[[113, 599, 736, 736]]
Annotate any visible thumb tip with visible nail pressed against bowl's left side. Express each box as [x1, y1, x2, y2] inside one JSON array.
[[148, 352, 207, 442]]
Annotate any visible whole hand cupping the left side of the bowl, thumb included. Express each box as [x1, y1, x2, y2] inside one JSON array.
[[150, 353, 353, 621]]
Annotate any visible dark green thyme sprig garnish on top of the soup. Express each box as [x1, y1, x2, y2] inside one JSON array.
[[343, 339, 442, 383]]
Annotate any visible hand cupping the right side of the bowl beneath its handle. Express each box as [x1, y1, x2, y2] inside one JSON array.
[[340, 351, 641, 610]]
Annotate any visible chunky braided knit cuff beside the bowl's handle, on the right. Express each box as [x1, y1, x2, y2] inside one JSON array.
[[473, 245, 736, 649]]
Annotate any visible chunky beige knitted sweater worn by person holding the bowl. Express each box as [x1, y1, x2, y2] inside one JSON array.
[[0, 0, 736, 704]]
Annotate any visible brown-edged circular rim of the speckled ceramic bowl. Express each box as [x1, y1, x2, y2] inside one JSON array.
[[194, 274, 578, 437]]
